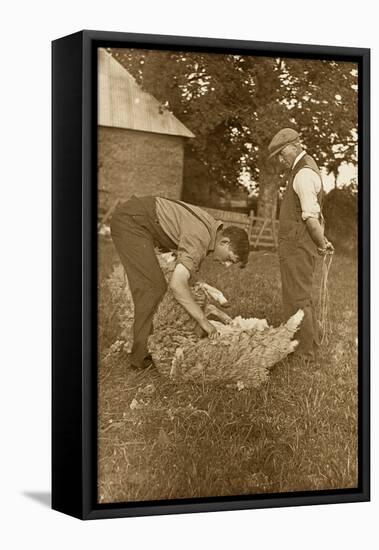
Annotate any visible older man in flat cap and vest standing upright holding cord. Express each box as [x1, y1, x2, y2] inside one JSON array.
[[268, 128, 333, 361]]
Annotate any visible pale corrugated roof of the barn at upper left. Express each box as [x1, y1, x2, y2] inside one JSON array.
[[98, 48, 195, 138]]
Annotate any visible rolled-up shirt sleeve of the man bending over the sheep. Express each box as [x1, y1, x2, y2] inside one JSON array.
[[176, 228, 210, 274]]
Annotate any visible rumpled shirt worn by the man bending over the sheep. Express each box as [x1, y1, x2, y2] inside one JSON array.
[[156, 197, 222, 273]]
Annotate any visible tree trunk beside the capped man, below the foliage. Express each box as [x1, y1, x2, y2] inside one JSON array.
[[257, 161, 279, 218]]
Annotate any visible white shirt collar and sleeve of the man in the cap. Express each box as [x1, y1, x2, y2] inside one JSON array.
[[292, 151, 322, 221]]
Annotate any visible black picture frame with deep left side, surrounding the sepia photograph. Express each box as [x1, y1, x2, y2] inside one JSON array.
[[52, 30, 370, 519]]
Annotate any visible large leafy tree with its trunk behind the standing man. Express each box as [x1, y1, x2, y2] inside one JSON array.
[[110, 49, 358, 217]]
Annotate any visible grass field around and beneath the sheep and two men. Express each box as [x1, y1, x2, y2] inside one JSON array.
[[98, 241, 357, 503]]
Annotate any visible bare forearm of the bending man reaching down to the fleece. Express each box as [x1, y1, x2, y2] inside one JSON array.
[[170, 263, 217, 338]]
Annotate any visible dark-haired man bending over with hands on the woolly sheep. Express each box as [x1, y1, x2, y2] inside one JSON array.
[[111, 196, 249, 368]]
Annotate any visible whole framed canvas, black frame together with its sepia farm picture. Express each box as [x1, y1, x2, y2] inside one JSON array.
[[52, 31, 370, 519]]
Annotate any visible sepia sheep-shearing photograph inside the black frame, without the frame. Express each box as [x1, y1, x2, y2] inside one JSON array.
[[96, 47, 360, 505]]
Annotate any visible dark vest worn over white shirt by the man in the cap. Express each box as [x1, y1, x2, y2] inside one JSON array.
[[279, 154, 323, 257]]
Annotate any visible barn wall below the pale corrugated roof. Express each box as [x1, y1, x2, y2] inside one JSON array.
[[98, 126, 184, 214]]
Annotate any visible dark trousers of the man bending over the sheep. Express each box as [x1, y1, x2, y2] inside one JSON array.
[[111, 197, 176, 366]]
